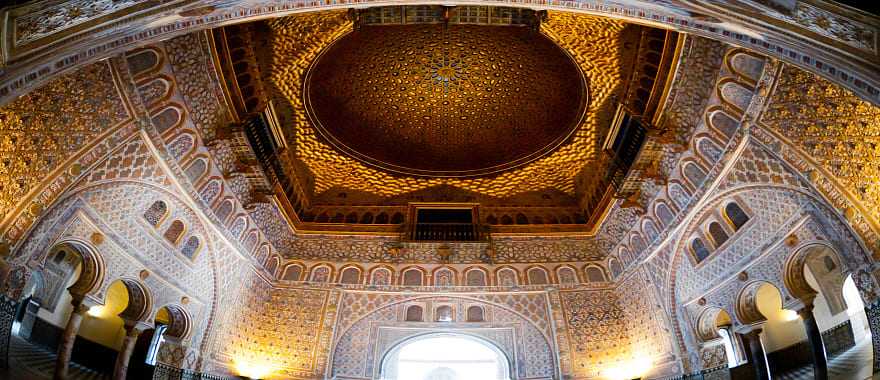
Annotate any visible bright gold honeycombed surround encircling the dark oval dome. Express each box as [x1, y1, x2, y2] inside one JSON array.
[[267, 11, 639, 198]]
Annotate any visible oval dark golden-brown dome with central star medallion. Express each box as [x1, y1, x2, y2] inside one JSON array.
[[303, 24, 588, 177]]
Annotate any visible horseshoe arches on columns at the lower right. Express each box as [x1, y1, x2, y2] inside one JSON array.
[[693, 242, 871, 378]]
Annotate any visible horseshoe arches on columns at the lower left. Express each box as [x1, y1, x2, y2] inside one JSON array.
[[11, 240, 193, 378]]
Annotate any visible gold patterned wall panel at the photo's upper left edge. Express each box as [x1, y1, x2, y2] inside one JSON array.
[[0, 61, 129, 240]]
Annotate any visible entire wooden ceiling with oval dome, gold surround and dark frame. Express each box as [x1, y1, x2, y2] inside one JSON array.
[[213, 6, 677, 230]]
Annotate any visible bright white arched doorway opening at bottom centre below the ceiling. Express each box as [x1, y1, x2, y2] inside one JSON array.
[[380, 333, 511, 380]]
